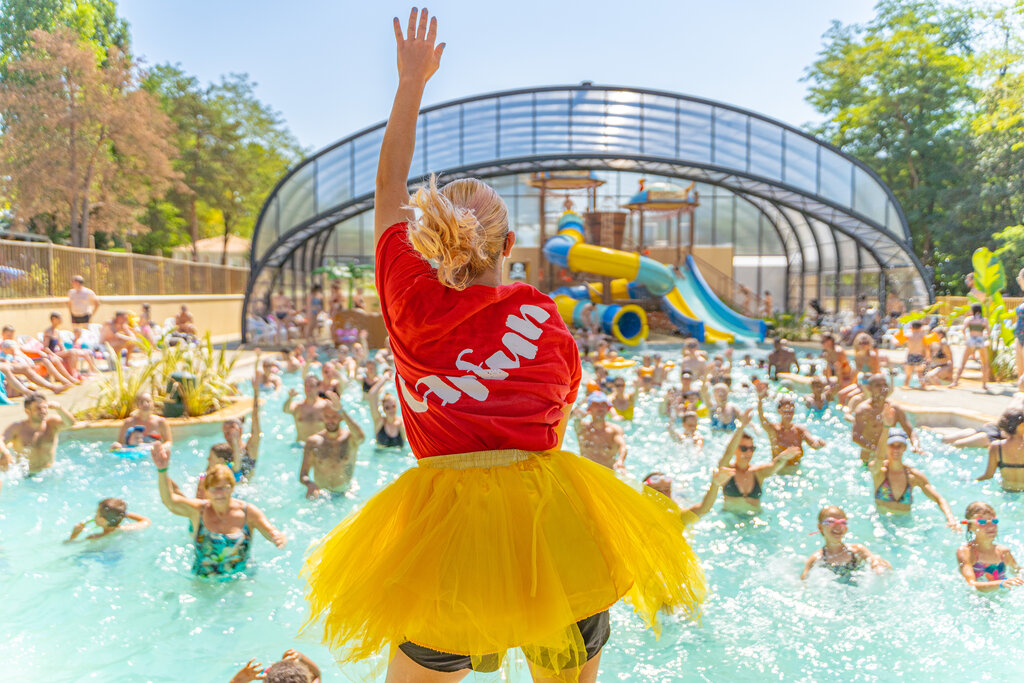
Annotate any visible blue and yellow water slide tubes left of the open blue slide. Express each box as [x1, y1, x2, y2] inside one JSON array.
[[544, 211, 732, 344]]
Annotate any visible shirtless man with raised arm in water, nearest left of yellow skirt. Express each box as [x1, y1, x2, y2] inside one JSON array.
[[299, 391, 366, 501]]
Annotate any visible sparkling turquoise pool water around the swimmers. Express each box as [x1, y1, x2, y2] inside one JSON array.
[[0, 350, 1024, 683]]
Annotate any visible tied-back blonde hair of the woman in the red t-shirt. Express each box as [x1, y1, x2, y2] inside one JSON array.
[[409, 175, 509, 290]]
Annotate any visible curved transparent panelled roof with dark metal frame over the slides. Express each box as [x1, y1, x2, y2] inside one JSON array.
[[242, 83, 934, 336]]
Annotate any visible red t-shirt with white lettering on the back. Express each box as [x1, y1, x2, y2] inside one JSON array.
[[376, 223, 580, 458]]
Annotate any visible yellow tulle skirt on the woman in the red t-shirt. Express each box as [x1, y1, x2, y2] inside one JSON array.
[[302, 451, 706, 679]]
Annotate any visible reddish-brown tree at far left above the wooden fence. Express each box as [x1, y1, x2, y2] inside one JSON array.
[[0, 28, 176, 247]]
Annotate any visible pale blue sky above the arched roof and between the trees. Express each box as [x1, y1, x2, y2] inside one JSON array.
[[119, 0, 874, 151]]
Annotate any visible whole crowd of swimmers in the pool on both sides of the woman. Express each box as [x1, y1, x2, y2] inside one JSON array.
[[0, 288, 1024, 682]]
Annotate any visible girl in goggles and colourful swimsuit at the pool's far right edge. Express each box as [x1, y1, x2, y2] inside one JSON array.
[[956, 501, 1024, 593]]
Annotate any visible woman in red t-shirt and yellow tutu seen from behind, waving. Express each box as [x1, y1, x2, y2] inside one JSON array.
[[303, 9, 706, 683]]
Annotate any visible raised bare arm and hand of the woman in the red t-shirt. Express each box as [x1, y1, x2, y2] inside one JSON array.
[[374, 7, 444, 244]]
